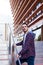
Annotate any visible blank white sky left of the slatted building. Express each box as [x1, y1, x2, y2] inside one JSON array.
[[0, 0, 13, 23]]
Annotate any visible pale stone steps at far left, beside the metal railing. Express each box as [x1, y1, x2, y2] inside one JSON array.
[[0, 41, 9, 65]]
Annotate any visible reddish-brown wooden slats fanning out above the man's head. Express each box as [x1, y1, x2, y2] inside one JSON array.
[[10, 0, 43, 33]]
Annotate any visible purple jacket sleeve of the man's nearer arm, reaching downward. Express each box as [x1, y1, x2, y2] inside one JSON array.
[[19, 34, 33, 55]]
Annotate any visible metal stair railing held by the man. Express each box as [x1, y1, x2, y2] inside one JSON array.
[[8, 24, 21, 65]]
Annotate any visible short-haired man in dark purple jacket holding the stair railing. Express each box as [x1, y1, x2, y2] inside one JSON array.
[[16, 23, 35, 65]]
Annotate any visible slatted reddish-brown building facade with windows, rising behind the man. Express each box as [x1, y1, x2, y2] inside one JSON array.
[[10, 0, 43, 40]]
